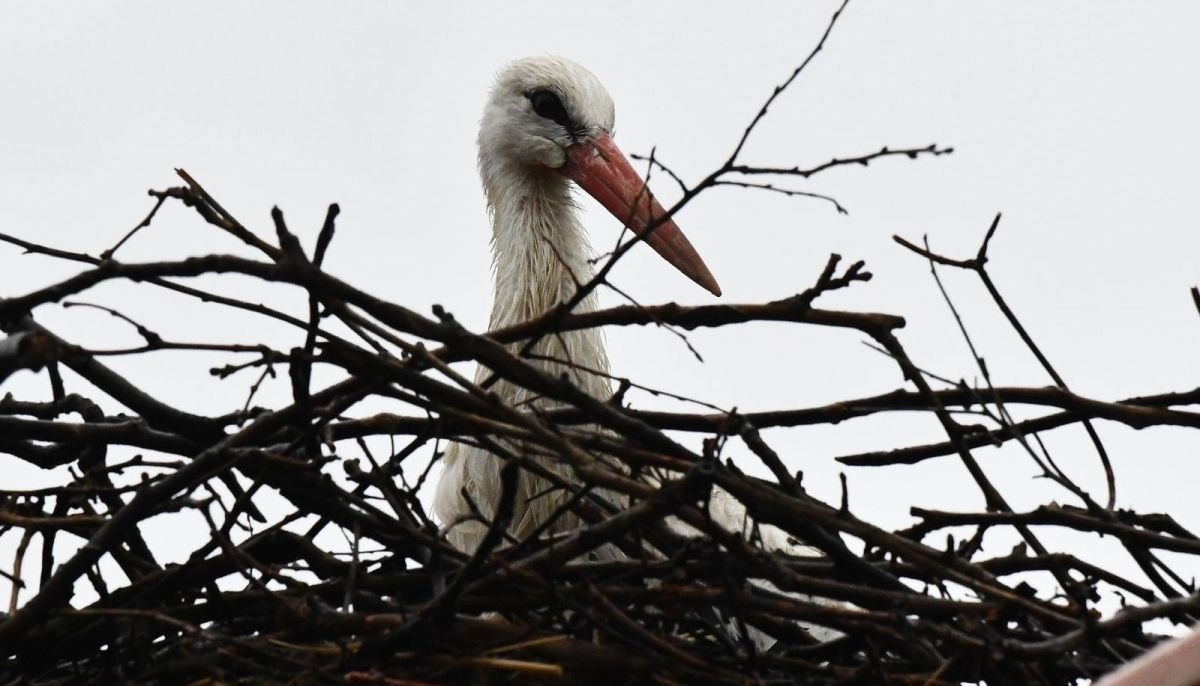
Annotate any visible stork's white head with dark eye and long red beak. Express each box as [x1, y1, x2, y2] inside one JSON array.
[[479, 56, 721, 295]]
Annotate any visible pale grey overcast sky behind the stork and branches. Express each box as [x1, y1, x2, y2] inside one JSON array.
[[0, 0, 1200, 614]]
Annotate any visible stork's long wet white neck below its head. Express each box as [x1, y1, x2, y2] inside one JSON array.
[[480, 166, 611, 402]]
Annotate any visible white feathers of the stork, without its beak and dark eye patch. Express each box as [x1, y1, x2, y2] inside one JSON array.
[[433, 56, 835, 644]]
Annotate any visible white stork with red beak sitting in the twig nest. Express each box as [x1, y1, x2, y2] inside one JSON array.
[[432, 55, 836, 640]]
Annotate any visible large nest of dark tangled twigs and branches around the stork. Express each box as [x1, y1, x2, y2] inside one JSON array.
[[0, 6, 1200, 686]]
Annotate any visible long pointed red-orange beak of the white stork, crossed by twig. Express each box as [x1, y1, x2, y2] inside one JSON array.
[[559, 133, 721, 295]]
